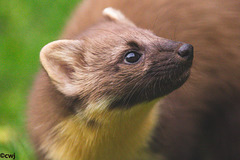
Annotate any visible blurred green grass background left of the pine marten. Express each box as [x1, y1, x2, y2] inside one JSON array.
[[0, 0, 79, 160]]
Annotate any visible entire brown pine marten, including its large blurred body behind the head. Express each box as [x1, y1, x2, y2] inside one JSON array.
[[28, 0, 240, 160]]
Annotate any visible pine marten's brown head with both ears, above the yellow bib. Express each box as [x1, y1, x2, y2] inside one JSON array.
[[40, 8, 193, 108]]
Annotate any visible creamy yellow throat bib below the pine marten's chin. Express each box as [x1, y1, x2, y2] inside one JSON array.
[[43, 98, 160, 160]]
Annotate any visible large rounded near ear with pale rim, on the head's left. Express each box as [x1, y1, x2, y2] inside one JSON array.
[[40, 40, 84, 96]]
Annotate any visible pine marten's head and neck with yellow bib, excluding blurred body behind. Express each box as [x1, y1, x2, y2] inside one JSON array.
[[29, 5, 193, 160]]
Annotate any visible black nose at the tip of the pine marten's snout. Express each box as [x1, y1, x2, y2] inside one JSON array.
[[178, 44, 193, 60]]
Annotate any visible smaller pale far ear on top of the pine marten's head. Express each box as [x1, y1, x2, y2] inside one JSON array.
[[103, 7, 135, 26]]
